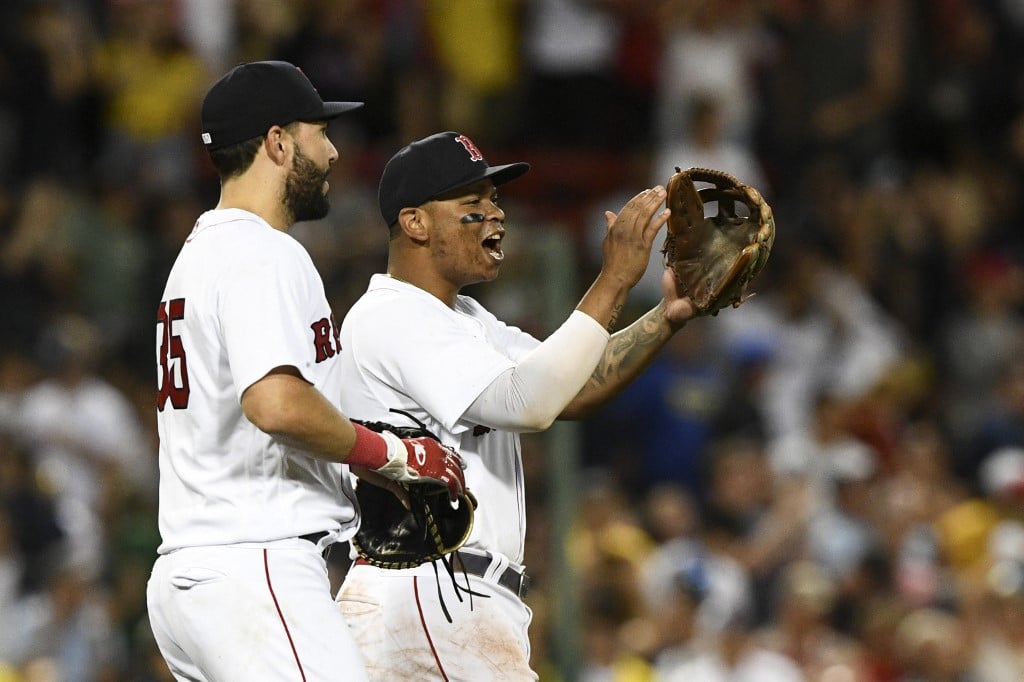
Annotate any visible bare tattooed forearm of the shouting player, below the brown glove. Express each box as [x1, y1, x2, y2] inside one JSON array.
[[559, 301, 678, 420]]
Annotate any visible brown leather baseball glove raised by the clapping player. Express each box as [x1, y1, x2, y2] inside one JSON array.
[[662, 167, 775, 315]]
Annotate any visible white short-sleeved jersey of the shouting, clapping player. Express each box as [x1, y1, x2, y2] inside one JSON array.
[[340, 274, 540, 564]]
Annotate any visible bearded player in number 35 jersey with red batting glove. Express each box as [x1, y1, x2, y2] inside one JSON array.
[[146, 61, 464, 681]]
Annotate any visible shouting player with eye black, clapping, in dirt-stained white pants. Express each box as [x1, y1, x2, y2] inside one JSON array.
[[338, 132, 693, 681]]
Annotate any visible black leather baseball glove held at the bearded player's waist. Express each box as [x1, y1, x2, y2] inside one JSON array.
[[351, 410, 476, 568]]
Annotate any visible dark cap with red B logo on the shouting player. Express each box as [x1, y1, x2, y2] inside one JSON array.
[[377, 131, 529, 225]]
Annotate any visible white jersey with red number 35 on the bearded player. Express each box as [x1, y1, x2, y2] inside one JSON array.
[[150, 204, 355, 554]]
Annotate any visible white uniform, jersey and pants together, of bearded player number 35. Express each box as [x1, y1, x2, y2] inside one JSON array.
[[146, 209, 366, 682]]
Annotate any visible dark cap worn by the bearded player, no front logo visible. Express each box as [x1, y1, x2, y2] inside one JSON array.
[[202, 61, 362, 150]]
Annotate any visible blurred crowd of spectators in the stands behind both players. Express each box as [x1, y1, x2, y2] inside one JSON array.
[[0, 0, 1024, 682]]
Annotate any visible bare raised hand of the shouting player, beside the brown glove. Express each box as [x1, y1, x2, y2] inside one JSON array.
[[601, 185, 669, 288]]
